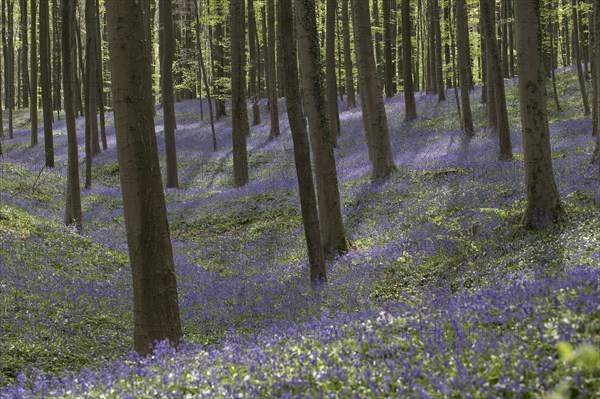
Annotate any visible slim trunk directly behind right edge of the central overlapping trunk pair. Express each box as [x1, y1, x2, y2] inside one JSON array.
[[325, 0, 340, 147]]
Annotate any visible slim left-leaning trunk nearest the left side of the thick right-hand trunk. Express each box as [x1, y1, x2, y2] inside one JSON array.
[[481, 0, 512, 160]]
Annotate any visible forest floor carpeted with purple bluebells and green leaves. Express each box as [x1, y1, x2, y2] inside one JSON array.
[[0, 69, 600, 398]]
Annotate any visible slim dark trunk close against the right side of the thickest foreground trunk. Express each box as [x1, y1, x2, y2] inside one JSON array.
[[159, 0, 179, 188]]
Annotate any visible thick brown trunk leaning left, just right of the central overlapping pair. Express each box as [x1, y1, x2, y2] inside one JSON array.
[[352, 0, 396, 180]]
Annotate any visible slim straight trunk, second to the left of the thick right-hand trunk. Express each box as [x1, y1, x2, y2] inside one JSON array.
[[456, 0, 474, 135]]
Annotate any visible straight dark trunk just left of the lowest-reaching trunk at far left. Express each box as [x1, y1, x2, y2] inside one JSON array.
[[40, 1, 54, 168]]
